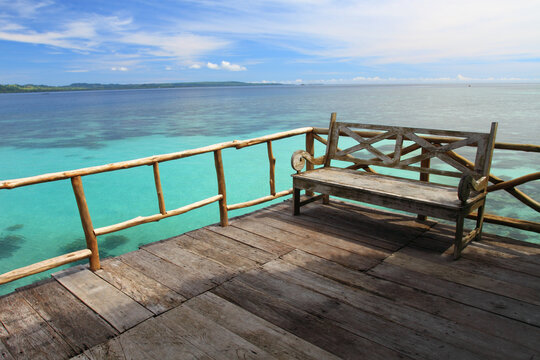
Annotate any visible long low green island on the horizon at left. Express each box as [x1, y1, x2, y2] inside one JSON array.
[[0, 81, 281, 93]]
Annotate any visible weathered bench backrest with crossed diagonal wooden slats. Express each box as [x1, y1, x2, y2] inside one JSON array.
[[324, 113, 497, 179]]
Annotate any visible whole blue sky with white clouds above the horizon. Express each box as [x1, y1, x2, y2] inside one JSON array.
[[0, 0, 540, 85]]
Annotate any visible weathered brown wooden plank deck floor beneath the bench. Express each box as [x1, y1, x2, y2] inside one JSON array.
[[0, 202, 540, 359]]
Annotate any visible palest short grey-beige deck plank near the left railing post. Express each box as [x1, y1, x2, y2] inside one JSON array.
[[53, 268, 153, 332]]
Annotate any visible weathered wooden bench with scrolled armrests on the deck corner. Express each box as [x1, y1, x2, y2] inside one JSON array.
[[291, 113, 497, 259]]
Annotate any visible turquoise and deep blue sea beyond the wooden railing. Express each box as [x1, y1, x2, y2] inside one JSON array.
[[0, 84, 540, 294]]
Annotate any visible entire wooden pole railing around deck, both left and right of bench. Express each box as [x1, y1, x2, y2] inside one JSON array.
[[0, 127, 540, 284]]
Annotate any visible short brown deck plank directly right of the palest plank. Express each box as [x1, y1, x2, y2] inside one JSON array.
[[96, 258, 186, 315]]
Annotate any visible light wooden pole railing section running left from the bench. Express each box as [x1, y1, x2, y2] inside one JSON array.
[[0, 127, 313, 284]]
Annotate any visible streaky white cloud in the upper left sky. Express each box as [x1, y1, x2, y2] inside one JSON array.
[[0, 0, 230, 61]]
